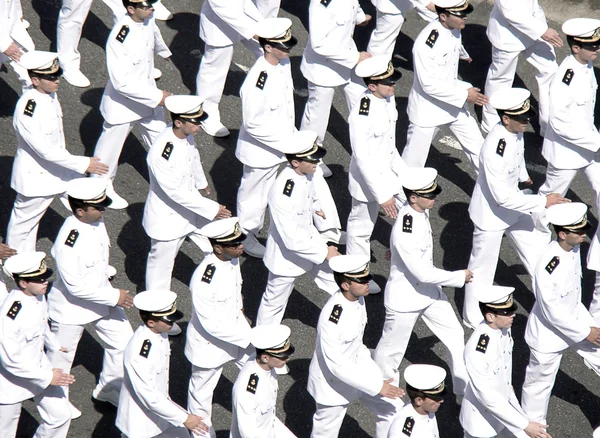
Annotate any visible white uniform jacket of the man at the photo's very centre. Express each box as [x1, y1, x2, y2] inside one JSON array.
[[263, 165, 327, 277]]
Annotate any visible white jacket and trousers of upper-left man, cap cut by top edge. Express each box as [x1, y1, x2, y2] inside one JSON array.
[[94, 14, 171, 179]]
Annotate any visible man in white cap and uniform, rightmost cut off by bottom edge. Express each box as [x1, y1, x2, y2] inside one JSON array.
[[460, 285, 551, 438]]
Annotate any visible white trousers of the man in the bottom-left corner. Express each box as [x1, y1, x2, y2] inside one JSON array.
[[0, 386, 71, 438]]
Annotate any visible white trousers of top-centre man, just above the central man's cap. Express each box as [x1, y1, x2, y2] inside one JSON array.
[[300, 78, 366, 146]]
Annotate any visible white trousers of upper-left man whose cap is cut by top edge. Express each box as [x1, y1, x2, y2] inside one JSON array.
[[92, 106, 167, 179]]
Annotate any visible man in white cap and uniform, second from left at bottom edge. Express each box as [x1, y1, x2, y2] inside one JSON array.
[[116, 290, 208, 438]]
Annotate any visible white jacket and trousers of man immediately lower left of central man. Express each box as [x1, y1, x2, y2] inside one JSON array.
[[185, 253, 253, 437]]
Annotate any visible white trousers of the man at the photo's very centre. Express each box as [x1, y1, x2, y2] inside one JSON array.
[[256, 261, 339, 325]]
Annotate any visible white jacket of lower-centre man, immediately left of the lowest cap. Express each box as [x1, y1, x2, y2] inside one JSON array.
[[308, 291, 385, 406]]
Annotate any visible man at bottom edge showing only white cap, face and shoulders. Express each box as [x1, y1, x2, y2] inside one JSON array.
[[387, 364, 446, 438]]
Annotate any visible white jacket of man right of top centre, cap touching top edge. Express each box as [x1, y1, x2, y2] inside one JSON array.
[[407, 20, 472, 128]]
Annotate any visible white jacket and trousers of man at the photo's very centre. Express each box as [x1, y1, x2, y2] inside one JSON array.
[[256, 165, 338, 325]]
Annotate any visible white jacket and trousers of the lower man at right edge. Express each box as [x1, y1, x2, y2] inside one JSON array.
[[521, 241, 600, 424]]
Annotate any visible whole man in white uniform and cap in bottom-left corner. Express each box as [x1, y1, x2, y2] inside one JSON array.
[[0, 252, 75, 438]]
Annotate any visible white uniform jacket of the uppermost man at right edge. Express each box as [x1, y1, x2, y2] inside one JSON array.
[[542, 55, 600, 169]]
